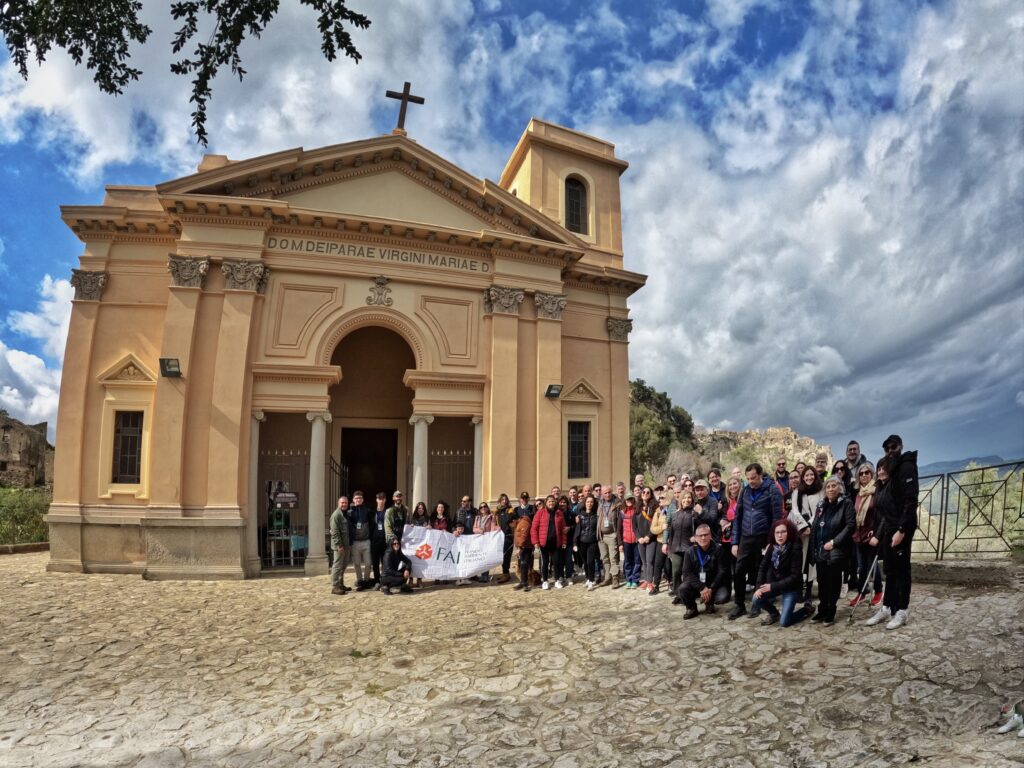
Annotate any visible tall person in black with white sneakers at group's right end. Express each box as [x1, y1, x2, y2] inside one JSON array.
[[867, 434, 918, 630]]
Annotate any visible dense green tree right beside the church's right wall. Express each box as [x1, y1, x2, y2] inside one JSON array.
[[630, 379, 693, 475]]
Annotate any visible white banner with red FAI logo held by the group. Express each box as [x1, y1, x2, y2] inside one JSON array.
[[401, 525, 505, 580]]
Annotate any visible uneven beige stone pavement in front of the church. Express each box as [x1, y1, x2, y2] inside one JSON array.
[[0, 553, 1024, 768]]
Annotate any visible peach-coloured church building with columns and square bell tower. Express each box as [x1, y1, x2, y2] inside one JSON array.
[[47, 120, 645, 579]]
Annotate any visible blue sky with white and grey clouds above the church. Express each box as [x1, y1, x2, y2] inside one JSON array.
[[0, 0, 1024, 462]]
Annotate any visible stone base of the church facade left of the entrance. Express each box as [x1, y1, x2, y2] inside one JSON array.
[[46, 510, 246, 581]]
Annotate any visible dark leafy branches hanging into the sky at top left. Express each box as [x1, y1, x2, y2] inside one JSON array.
[[0, 0, 370, 146]]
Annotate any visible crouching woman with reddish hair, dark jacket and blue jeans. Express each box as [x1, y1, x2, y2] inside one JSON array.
[[754, 518, 814, 627]]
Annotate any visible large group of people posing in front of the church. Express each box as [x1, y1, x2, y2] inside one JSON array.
[[331, 435, 918, 629]]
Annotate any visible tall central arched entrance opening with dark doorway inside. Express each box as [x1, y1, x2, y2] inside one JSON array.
[[330, 326, 416, 503]]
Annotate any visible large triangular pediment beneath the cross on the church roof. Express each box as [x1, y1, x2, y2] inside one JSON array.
[[150, 135, 587, 250]]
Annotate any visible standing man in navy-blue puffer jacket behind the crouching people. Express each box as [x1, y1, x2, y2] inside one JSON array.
[[729, 463, 783, 621]]
